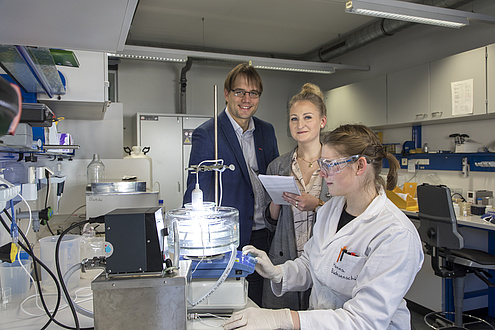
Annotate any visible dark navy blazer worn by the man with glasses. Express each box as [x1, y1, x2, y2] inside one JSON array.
[[183, 110, 279, 248]]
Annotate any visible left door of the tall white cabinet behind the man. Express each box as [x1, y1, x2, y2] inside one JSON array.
[[138, 115, 183, 211]]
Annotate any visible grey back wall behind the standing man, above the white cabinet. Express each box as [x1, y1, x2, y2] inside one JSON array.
[[118, 59, 317, 153]]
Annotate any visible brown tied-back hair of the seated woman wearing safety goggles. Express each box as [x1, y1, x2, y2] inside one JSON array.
[[321, 125, 399, 192]]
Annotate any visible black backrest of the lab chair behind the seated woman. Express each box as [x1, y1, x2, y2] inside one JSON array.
[[417, 183, 464, 249]]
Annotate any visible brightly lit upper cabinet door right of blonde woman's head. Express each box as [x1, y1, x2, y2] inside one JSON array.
[[325, 76, 387, 129]]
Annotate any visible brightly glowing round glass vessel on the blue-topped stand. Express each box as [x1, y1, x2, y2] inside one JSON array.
[[165, 202, 239, 257]]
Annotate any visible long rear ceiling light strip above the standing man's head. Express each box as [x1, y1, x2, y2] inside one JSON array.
[[108, 45, 369, 74]]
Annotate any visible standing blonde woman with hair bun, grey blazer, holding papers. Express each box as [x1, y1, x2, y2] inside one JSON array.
[[263, 83, 329, 310]]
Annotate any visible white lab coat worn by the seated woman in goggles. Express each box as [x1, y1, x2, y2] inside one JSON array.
[[271, 190, 424, 330]]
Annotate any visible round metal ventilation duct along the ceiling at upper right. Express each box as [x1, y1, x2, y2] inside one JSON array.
[[304, 0, 474, 62]]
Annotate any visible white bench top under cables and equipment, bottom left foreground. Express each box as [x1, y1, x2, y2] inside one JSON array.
[[0, 272, 257, 330]]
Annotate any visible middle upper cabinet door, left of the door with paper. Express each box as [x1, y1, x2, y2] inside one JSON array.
[[387, 64, 430, 125]]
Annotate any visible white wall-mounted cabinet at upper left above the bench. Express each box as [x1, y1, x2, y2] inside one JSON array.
[[38, 51, 108, 119]]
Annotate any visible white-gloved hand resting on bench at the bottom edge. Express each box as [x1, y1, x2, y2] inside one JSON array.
[[223, 307, 294, 330]]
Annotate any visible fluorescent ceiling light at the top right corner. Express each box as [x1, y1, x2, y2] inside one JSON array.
[[345, 0, 495, 28]]
